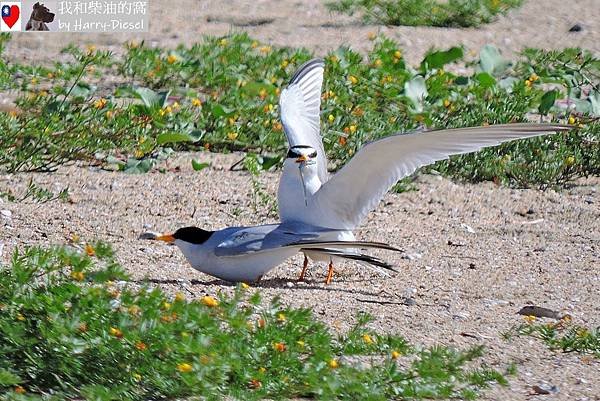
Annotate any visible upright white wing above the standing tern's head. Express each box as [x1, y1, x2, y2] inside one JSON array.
[[279, 58, 328, 182]]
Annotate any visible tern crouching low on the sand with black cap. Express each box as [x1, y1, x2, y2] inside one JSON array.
[[148, 223, 400, 283]]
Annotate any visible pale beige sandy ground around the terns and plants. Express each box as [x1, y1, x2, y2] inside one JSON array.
[[0, 0, 600, 401]]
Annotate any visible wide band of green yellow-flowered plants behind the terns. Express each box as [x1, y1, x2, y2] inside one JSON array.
[[0, 34, 600, 189]]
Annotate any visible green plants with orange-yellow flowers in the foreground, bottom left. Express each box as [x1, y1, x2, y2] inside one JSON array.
[[0, 243, 505, 400]]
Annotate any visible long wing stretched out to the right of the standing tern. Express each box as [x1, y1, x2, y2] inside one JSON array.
[[313, 123, 573, 229]]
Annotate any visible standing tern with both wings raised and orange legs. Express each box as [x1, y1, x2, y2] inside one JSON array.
[[277, 59, 574, 281]]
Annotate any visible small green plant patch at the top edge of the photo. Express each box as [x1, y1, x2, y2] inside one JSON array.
[[326, 0, 523, 27]]
